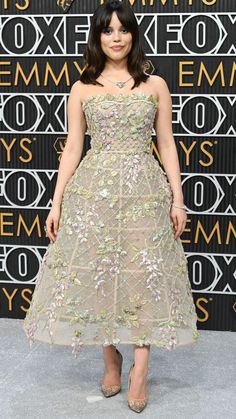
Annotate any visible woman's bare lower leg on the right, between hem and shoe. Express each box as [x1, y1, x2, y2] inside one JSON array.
[[129, 345, 150, 399]]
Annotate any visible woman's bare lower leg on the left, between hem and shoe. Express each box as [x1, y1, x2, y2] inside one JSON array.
[[103, 345, 120, 386]]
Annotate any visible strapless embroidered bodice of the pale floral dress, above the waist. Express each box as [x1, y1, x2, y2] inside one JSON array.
[[83, 93, 158, 152]]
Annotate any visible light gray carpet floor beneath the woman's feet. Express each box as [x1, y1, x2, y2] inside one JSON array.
[[0, 319, 236, 419]]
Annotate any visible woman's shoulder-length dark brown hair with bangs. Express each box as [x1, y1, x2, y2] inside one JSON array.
[[80, 0, 149, 89]]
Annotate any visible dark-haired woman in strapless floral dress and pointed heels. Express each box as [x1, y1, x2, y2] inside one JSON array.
[[24, 0, 199, 412]]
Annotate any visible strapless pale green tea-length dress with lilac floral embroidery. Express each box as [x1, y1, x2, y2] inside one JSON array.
[[23, 93, 199, 357]]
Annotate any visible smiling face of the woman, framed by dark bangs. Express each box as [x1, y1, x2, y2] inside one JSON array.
[[101, 12, 132, 61]]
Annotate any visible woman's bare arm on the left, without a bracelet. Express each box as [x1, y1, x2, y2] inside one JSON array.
[[46, 81, 86, 241]]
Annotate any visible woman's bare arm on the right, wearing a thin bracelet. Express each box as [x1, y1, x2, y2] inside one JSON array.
[[154, 76, 187, 238]]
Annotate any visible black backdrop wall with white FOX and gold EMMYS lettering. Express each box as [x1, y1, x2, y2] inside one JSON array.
[[0, 0, 236, 331]]
